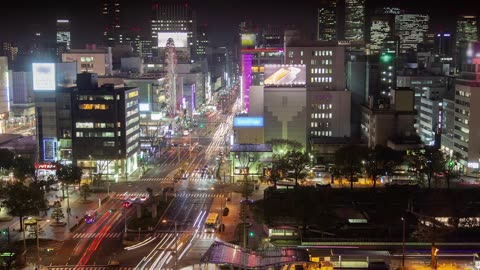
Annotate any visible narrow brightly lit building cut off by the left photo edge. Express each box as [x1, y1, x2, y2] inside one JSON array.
[[0, 56, 10, 134]]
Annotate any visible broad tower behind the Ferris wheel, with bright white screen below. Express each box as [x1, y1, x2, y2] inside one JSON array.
[[151, 0, 197, 58]]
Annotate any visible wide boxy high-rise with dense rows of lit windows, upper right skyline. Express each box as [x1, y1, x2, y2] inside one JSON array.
[[395, 14, 430, 53]]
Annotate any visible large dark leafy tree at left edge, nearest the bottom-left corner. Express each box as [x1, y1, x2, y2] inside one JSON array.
[[2, 182, 47, 231]]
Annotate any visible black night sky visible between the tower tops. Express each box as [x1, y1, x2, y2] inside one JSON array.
[[0, 0, 480, 48]]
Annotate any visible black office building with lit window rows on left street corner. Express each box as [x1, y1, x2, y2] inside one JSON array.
[[71, 73, 140, 180]]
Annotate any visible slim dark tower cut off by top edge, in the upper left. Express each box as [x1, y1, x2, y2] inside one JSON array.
[[102, 0, 120, 46]]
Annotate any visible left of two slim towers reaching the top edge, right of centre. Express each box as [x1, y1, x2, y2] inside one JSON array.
[[317, 0, 337, 41]]
